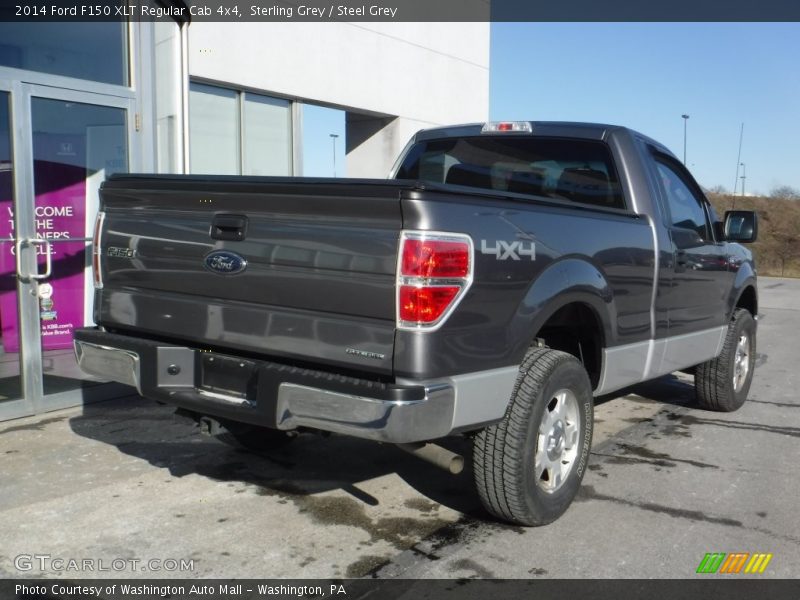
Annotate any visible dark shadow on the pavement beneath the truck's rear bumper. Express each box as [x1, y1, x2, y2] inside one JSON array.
[[70, 397, 485, 516]]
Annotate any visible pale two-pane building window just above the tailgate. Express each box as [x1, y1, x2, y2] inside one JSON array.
[[189, 83, 292, 175]]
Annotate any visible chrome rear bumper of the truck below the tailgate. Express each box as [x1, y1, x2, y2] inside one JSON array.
[[75, 339, 456, 444]]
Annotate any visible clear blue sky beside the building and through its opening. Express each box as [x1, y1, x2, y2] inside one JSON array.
[[303, 23, 800, 194]]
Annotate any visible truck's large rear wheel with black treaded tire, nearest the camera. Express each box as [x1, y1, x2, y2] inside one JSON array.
[[473, 348, 594, 526]]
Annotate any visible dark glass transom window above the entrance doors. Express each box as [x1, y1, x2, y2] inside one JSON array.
[[0, 21, 128, 85]]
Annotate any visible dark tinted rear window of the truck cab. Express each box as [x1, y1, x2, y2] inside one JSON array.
[[397, 136, 625, 208]]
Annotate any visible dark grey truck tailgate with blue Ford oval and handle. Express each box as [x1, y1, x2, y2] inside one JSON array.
[[95, 176, 407, 374]]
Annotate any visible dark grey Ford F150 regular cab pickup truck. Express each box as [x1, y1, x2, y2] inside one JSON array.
[[75, 122, 758, 525]]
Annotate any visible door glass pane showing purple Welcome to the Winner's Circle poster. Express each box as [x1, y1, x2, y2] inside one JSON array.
[[31, 98, 128, 394]]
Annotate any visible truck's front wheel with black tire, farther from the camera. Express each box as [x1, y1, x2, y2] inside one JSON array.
[[694, 308, 756, 412]]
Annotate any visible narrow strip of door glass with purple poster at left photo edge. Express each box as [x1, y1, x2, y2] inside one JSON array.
[[0, 92, 22, 403]]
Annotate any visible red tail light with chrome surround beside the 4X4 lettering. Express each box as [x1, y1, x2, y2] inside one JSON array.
[[397, 231, 473, 330]]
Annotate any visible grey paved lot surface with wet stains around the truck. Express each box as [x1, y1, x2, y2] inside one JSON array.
[[0, 278, 800, 578]]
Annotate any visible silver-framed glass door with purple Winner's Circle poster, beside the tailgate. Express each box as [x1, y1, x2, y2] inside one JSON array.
[[0, 84, 133, 412]]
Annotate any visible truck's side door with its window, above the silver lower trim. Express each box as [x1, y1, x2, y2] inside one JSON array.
[[656, 155, 730, 337]]
